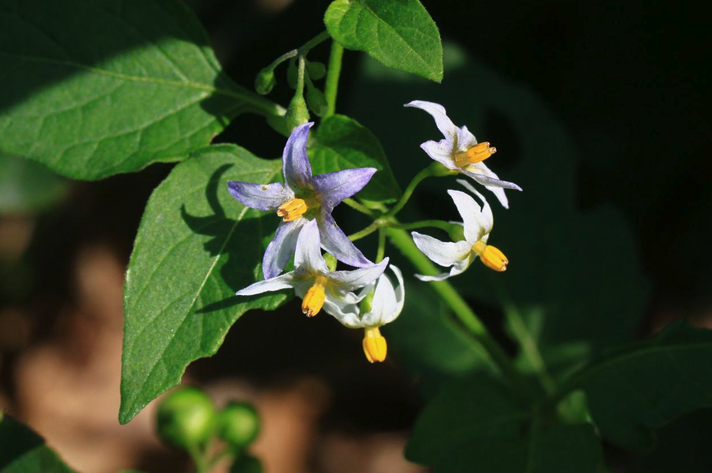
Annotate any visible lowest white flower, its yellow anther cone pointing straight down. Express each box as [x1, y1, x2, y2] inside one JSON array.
[[336, 265, 405, 363]]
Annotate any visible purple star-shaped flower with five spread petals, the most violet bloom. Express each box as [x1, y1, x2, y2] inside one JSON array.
[[228, 122, 376, 279]]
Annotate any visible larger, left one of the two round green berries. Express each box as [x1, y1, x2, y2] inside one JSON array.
[[156, 387, 215, 449]]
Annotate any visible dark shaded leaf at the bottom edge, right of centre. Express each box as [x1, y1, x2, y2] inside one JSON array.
[[406, 376, 601, 473]]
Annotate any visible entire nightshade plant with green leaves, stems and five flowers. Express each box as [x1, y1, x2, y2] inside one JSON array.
[[0, 0, 712, 473]]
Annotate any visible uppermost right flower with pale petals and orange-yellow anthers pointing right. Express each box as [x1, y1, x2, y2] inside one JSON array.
[[405, 100, 522, 208]]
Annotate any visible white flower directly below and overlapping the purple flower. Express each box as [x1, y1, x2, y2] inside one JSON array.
[[237, 220, 388, 318]]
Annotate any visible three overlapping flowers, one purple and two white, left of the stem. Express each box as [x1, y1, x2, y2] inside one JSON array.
[[228, 123, 403, 362]]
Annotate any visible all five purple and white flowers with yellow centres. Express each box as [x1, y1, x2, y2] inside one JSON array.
[[228, 101, 521, 363]]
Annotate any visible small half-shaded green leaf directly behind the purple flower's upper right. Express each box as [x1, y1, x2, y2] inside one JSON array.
[[309, 115, 400, 202]]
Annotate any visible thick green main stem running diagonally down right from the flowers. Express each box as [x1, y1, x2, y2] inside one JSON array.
[[386, 228, 531, 395]]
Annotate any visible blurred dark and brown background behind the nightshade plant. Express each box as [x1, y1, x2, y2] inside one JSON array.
[[0, 0, 712, 473]]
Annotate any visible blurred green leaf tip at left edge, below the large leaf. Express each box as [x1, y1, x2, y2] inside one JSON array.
[[0, 152, 69, 214]]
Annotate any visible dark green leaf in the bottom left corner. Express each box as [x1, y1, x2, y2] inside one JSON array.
[[0, 412, 74, 473]]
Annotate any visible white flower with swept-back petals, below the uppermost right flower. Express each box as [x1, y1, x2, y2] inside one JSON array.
[[412, 179, 509, 281]]
